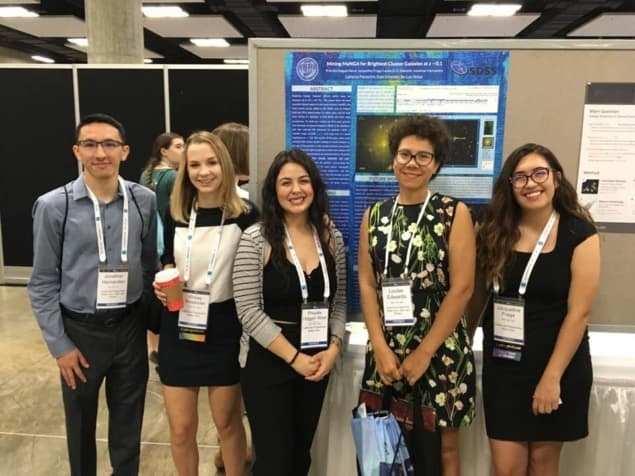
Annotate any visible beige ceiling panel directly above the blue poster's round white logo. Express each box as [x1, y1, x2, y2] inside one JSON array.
[[278, 15, 377, 38]]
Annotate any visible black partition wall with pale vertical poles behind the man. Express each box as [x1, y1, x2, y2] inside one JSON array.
[[0, 64, 249, 284]]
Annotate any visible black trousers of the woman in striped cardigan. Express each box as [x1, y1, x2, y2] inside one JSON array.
[[241, 339, 328, 476]]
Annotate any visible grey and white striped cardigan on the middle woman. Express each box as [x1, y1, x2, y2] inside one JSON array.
[[233, 223, 346, 367]]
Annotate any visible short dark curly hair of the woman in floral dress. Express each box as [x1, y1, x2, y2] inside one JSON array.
[[388, 115, 450, 178]]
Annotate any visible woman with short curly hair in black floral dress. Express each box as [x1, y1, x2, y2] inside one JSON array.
[[359, 116, 476, 475]]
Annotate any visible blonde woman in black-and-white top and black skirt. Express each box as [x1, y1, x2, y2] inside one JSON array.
[[155, 132, 257, 475]]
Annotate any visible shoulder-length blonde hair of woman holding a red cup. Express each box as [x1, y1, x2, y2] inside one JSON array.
[[170, 131, 249, 223]]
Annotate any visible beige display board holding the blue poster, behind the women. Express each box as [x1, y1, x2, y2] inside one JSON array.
[[249, 39, 635, 330]]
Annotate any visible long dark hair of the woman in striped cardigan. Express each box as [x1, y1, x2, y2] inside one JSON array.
[[262, 149, 330, 269]]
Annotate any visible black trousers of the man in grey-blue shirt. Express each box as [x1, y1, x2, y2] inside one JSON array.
[[62, 306, 148, 476]]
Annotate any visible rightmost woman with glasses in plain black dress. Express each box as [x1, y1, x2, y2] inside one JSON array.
[[469, 144, 600, 476]]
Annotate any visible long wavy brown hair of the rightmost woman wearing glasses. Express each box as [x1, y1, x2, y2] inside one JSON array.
[[476, 143, 593, 288]]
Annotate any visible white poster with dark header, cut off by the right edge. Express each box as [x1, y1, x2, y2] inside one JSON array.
[[577, 83, 635, 233]]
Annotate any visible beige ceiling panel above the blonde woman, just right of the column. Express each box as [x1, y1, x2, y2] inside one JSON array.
[[143, 15, 243, 38]]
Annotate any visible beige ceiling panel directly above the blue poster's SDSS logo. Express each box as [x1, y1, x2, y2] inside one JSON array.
[[426, 13, 540, 38]]
